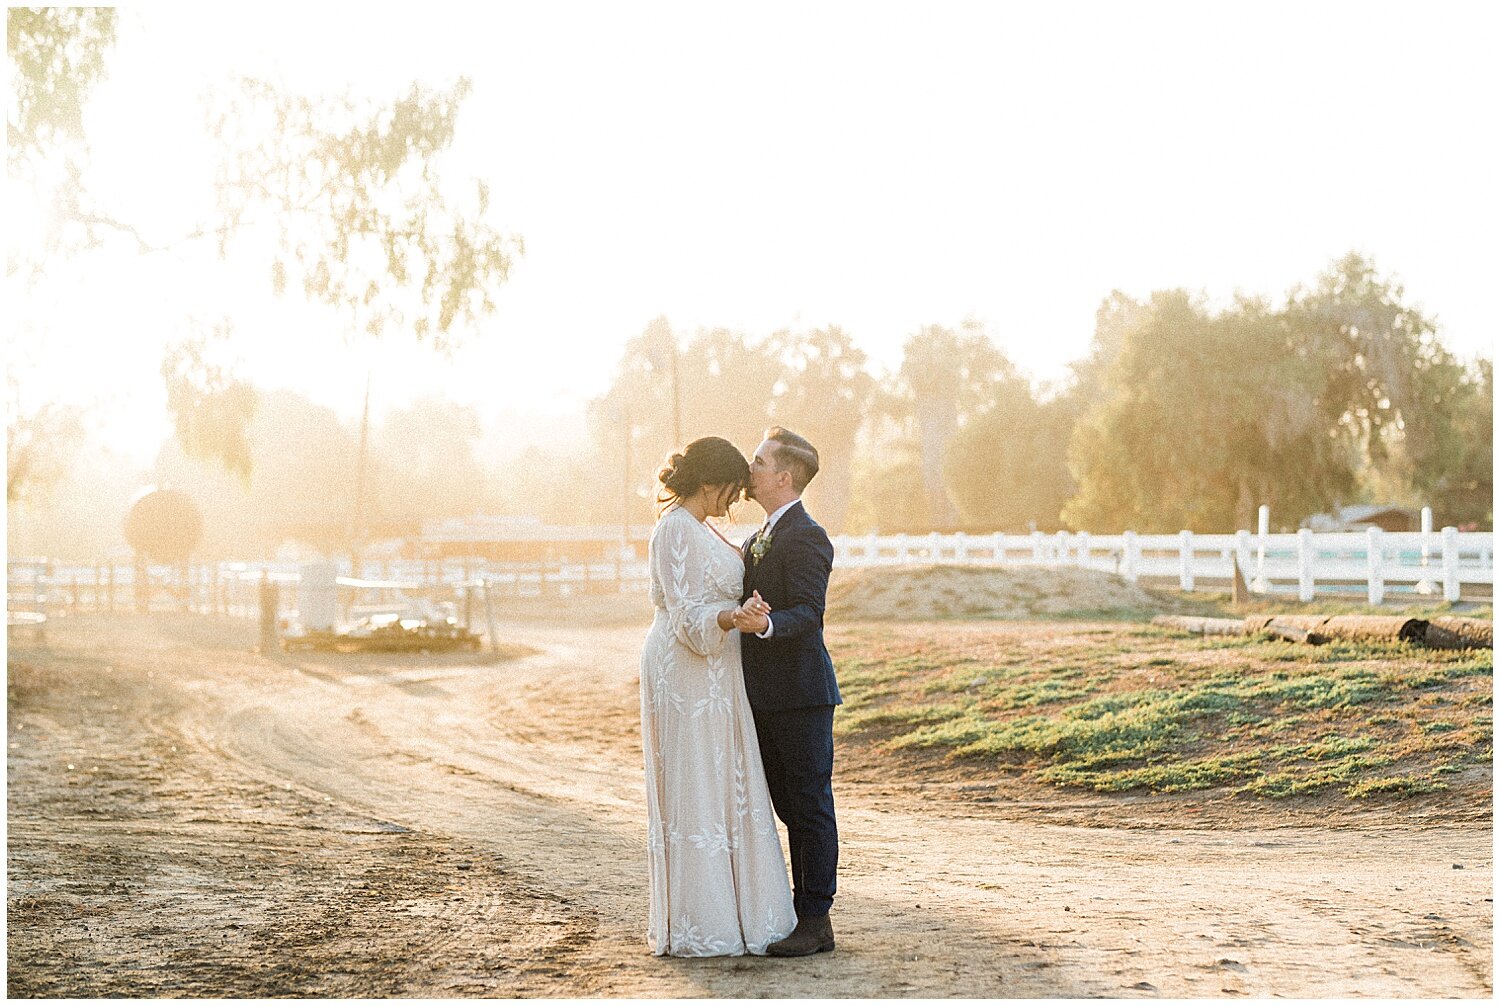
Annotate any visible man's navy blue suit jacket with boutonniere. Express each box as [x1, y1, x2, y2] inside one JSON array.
[[740, 501, 843, 709]]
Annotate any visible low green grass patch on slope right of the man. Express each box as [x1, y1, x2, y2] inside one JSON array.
[[831, 622, 1493, 799]]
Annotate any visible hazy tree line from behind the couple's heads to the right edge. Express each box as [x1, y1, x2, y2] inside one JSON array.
[[579, 253, 1494, 534]]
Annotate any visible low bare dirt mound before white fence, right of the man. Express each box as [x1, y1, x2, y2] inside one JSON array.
[[828, 565, 1170, 621]]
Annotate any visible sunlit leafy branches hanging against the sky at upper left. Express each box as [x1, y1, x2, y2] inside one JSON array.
[[6, 14, 524, 503]]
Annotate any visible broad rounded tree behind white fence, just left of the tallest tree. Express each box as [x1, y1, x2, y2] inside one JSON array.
[[1064, 291, 1353, 532]]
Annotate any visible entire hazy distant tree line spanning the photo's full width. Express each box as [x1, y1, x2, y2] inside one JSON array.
[[11, 248, 1494, 558]]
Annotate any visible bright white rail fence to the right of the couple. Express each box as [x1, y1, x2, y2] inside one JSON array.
[[834, 528, 1494, 604]]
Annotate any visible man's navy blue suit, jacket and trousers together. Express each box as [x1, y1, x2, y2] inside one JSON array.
[[740, 501, 843, 918]]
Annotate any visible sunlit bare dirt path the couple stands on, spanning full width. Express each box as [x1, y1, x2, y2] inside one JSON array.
[[8, 618, 1493, 997]]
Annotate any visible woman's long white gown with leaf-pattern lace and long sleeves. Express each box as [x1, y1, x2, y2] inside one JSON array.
[[641, 508, 797, 957]]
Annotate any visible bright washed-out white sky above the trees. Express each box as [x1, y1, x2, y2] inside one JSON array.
[[11, 3, 1500, 460]]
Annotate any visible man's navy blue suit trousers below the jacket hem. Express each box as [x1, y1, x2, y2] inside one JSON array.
[[755, 706, 839, 919]]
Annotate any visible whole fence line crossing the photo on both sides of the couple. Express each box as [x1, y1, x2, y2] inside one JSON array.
[[6, 528, 1494, 625]]
